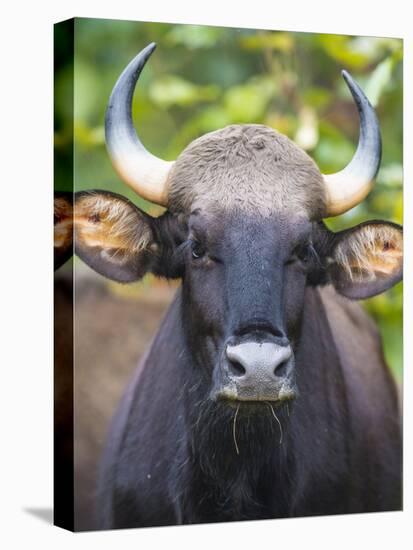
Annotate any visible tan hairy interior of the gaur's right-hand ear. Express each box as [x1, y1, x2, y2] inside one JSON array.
[[335, 225, 403, 281]]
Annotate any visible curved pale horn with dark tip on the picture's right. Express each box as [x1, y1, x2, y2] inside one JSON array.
[[323, 71, 381, 216]]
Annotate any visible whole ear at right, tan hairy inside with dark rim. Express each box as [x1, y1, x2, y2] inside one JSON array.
[[329, 222, 403, 299]]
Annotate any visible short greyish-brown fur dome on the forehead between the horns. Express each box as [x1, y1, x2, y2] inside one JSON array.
[[169, 124, 326, 219]]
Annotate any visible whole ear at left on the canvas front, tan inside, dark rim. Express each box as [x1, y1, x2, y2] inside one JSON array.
[[74, 191, 157, 283]]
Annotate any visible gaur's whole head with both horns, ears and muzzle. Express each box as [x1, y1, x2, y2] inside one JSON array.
[[66, 44, 402, 410]]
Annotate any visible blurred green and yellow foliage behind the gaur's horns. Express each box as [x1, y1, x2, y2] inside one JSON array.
[[56, 19, 403, 380]]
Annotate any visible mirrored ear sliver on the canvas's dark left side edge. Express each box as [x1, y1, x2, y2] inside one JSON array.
[[53, 192, 73, 271]]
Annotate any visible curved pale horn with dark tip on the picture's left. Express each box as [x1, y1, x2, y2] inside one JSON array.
[[105, 43, 173, 206]]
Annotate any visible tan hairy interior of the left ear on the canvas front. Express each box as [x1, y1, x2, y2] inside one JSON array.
[[74, 193, 151, 254]]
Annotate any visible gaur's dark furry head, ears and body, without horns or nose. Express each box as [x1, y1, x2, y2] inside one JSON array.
[[53, 125, 402, 528]]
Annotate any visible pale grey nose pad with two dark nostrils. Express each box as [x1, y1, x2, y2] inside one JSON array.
[[226, 342, 292, 377]]
